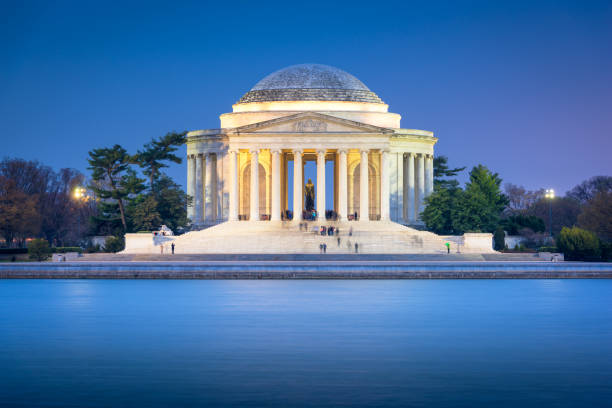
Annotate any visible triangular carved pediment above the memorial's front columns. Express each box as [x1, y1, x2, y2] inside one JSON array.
[[232, 112, 393, 133]]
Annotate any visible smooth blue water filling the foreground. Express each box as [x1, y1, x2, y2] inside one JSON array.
[[0, 280, 612, 407]]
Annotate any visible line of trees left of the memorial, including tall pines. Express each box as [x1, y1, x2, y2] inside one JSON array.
[[0, 132, 189, 247]]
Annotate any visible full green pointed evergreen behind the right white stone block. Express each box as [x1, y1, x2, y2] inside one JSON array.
[[453, 165, 508, 233]]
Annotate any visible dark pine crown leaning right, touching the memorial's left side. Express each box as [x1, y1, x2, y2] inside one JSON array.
[[134, 132, 187, 189]]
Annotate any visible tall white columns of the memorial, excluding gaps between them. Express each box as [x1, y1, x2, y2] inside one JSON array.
[[187, 149, 434, 224]]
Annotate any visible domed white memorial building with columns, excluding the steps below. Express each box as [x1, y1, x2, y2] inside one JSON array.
[[187, 64, 437, 229]]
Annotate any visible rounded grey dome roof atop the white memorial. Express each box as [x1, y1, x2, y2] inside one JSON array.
[[238, 64, 383, 103]]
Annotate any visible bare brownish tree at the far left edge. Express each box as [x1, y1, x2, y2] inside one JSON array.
[[0, 176, 41, 246]]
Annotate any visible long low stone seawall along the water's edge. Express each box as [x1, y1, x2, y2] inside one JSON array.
[[0, 261, 612, 279]]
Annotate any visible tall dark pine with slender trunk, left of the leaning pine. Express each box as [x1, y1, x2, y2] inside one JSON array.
[[88, 144, 137, 231]]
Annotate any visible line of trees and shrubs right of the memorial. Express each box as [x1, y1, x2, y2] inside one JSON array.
[[421, 156, 612, 259]]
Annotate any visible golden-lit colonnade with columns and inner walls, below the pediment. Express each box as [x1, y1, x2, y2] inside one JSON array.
[[187, 147, 433, 224]]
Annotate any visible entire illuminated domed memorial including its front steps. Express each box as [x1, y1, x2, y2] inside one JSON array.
[[125, 64, 492, 253]]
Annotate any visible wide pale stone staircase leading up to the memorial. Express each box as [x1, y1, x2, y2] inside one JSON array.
[[165, 221, 464, 254]]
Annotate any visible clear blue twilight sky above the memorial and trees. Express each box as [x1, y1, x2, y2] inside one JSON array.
[[0, 0, 612, 192]]
